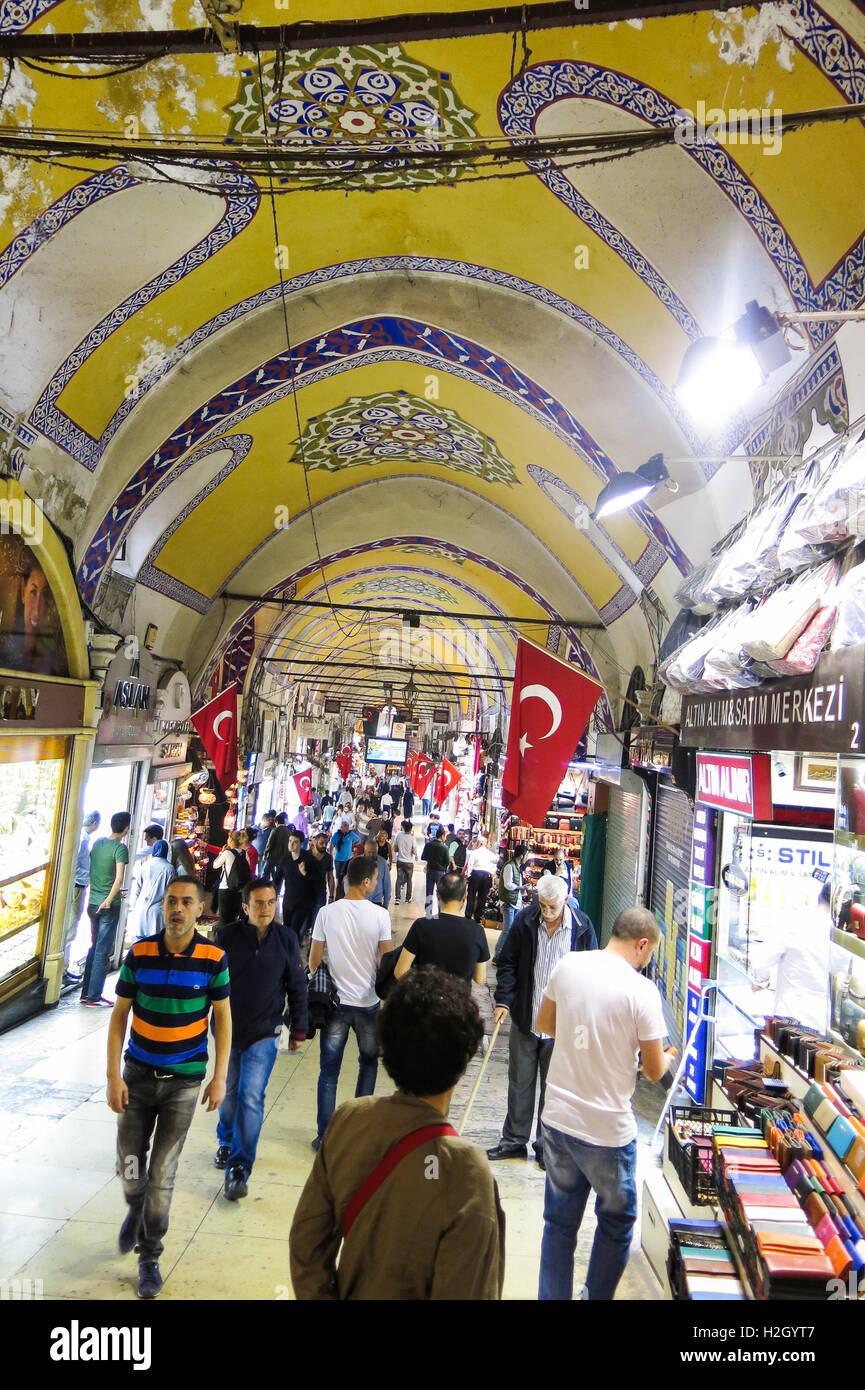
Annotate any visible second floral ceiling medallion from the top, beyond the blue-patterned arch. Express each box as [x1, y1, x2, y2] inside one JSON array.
[[291, 391, 519, 487]]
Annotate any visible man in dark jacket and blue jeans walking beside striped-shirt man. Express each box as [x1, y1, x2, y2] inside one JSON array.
[[214, 878, 307, 1202]]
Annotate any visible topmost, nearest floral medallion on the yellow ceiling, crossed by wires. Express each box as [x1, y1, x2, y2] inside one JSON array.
[[225, 44, 477, 189]]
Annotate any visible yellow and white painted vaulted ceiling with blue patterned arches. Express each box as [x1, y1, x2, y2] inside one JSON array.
[[0, 0, 865, 733]]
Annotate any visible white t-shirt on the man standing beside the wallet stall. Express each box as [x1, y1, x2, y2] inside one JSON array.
[[544, 951, 666, 1148]]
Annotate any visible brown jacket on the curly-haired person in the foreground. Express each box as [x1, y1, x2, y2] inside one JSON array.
[[289, 1091, 505, 1301]]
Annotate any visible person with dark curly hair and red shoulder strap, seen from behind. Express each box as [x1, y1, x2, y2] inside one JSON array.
[[289, 966, 505, 1301]]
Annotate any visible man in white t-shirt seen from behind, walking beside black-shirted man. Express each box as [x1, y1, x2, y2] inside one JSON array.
[[309, 858, 391, 1151]]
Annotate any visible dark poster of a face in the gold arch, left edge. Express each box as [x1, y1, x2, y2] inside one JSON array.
[[0, 535, 70, 676]]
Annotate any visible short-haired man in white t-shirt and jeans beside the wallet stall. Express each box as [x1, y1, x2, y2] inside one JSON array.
[[535, 908, 674, 1301]]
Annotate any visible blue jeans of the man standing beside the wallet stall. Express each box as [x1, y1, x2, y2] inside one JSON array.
[[538, 1125, 637, 1301]]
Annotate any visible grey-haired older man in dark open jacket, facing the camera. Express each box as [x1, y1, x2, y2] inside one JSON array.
[[487, 874, 598, 1168]]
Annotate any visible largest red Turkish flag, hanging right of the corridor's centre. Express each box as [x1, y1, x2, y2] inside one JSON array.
[[502, 638, 601, 826]]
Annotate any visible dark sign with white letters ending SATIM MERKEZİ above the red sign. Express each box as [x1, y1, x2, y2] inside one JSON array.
[[681, 646, 865, 753]]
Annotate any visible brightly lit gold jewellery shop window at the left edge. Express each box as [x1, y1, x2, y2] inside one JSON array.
[[0, 738, 65, 983]]
